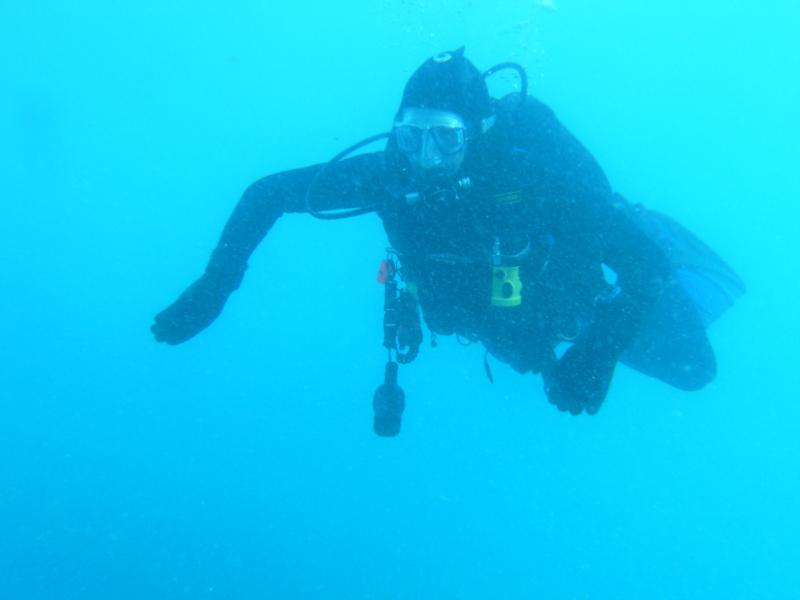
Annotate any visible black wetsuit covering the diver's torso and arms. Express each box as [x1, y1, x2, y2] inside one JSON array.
[[154, 97, 716, 410]]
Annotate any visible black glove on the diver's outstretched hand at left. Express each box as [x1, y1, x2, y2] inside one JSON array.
[[150, 277, 228, 345]]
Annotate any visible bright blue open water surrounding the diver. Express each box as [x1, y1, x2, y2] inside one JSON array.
[[0, 0, 800, 600]]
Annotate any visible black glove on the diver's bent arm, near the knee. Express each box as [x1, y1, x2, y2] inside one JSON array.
[[543, 343, 617, 415]]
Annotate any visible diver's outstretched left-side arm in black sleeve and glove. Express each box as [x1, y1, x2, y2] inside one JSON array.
[[151, 153, 390, 344]]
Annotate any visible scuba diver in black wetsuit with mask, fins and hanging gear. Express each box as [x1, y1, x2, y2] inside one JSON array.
[[152, 48, 744, 436]]
